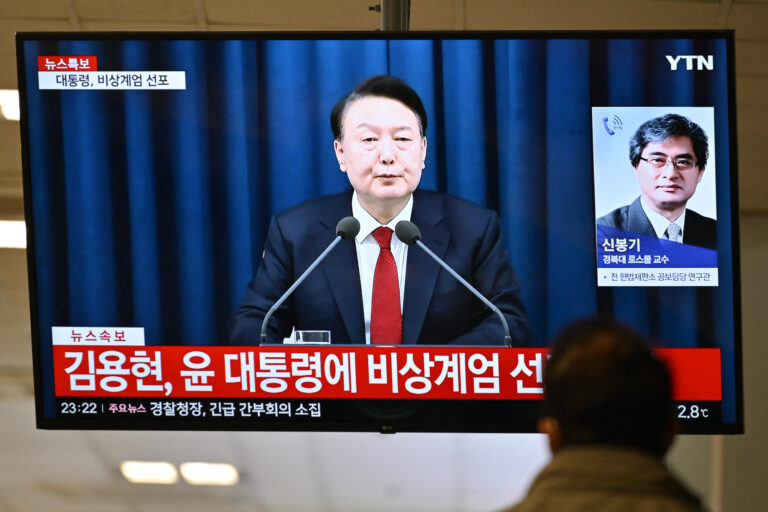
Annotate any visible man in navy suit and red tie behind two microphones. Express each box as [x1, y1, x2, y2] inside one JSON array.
[[229, 76, 528, 345]]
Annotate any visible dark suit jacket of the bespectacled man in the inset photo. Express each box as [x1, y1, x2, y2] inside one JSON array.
[[597, 197, 717, 249]]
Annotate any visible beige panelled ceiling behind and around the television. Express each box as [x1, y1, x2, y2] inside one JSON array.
[[0, 0, 768, 512]]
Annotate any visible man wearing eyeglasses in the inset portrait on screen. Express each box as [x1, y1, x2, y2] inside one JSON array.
[[597, 114, 717, 249]]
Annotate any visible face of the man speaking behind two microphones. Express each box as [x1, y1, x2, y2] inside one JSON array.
[[333, 96, 427, 207]]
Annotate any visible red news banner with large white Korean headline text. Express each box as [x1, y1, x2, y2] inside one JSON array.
[[53, 345, 722, 401]]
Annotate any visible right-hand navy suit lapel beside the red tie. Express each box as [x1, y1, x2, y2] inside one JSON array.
[[403, 192, 451, 344]]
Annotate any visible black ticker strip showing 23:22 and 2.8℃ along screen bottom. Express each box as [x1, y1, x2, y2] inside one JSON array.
[[56, 397, 722, 432]]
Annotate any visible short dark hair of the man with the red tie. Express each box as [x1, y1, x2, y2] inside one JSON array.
[[331, 75, 427, 140]]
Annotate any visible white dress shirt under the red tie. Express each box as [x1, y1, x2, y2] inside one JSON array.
[[352, 191, 413, 344]]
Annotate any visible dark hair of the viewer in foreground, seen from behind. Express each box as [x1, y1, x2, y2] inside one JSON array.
[[544, 320, 673, 456]]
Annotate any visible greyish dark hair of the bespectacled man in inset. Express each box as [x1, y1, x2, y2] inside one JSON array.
[[629, 114, 709, 170]]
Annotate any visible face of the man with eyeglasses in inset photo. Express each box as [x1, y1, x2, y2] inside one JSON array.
[[632, 136, 704, 214]]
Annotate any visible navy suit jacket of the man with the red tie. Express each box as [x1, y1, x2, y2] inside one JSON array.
[[229, 190, 528, 345]]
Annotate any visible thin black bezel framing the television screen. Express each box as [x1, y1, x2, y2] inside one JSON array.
[[16, 30, 744, 434]]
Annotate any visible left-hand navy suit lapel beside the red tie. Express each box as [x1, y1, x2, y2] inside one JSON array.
[[313, 193, 365, 343]]
